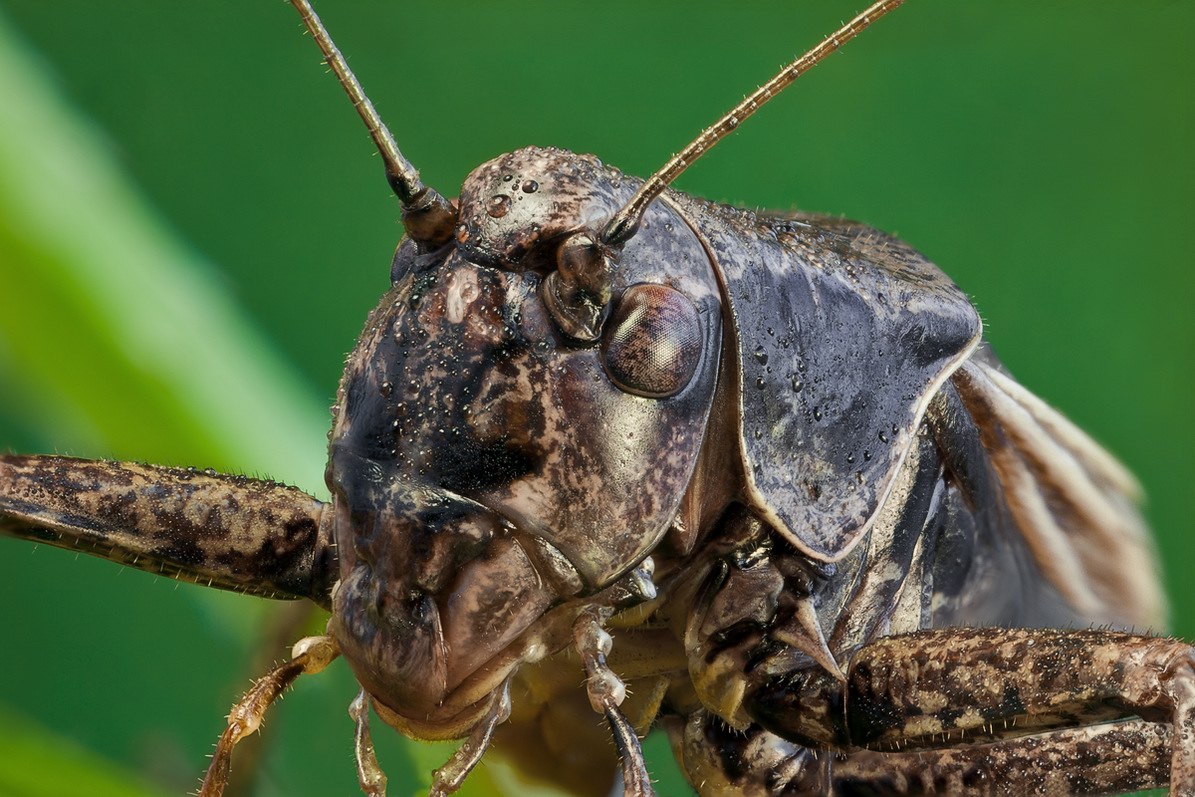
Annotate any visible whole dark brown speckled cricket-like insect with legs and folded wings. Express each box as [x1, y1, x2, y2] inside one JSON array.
[[0, 2, 1195, 795]]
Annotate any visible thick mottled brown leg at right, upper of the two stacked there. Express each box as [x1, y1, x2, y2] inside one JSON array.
[[846, 629, 1195, 795]]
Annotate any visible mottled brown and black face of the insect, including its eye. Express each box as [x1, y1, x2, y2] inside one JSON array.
[[329, 148, 721, 737]]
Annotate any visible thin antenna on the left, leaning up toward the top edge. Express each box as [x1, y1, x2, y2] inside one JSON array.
[[290, 0, 456, 250]]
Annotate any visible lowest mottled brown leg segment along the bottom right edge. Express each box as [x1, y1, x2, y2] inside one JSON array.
[[666, 711, 1171, 797]]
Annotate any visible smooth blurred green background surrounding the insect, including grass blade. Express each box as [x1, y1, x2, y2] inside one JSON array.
[[0, 0, 1195, 797]]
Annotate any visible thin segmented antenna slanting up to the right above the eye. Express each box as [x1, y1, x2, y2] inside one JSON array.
[[601, 0, 905, 249]]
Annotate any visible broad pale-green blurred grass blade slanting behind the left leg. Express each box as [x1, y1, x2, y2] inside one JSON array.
[[0, 7, 327, 490]]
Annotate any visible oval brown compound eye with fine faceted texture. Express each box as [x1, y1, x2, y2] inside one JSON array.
[[601, 283, 701, 398]]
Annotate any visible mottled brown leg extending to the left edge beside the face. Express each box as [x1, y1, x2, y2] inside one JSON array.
[[0, 455, 337, 608]]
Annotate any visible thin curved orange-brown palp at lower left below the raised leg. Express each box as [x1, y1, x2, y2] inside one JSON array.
[[196, 637, 341, 797]]
